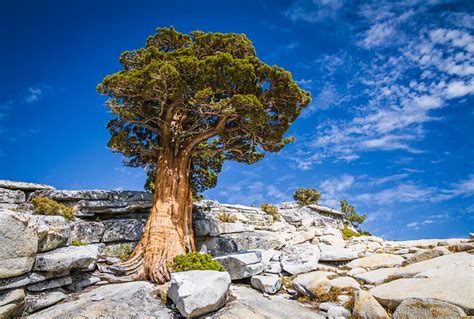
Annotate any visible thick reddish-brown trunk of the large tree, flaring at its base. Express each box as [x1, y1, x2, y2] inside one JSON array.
[[122, 150, 195, 283]]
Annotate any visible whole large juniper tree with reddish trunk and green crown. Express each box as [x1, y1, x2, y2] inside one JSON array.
[[98, 27, 310, 283]]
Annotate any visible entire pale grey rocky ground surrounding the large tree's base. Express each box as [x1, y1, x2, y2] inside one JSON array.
[[0, 181, 474, 318]]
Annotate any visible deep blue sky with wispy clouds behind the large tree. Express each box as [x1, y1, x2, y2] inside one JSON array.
[[0, 0, 474, 239]]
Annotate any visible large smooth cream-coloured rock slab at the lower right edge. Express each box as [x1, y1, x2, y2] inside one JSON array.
[[370, 272, 474, 315]]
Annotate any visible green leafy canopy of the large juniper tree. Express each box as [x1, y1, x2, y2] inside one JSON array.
[[97, 27, 310, 193]]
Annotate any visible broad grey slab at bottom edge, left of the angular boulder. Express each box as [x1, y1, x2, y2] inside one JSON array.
[[28, 281, 173, 319]]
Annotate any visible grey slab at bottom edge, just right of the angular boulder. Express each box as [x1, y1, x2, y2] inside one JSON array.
[[211, 285, 326, 319]]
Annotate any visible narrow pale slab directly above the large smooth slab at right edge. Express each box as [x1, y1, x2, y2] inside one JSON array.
[[395, 252, 474, 278]]
